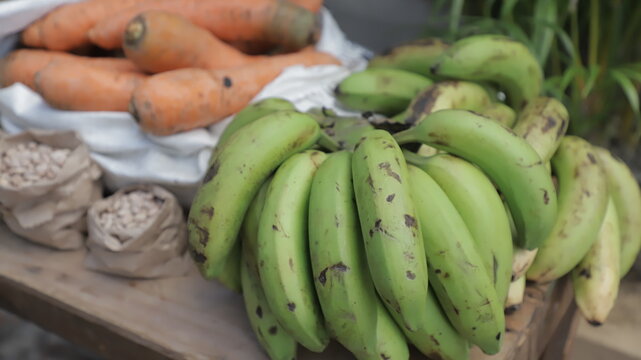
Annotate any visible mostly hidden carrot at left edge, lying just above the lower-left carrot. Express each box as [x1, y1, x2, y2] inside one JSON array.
[[0, 49, 138, 89]]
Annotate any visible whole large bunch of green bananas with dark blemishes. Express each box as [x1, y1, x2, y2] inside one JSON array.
[[188, 36, 641, 360]]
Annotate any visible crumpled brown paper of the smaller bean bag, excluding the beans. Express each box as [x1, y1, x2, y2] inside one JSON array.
[[85, 185, 193, 278]]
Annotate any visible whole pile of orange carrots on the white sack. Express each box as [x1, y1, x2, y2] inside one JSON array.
[[0, 0, 339, 135]]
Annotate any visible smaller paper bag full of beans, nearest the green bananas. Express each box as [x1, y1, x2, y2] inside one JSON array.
[[85, 185, 193, 278]]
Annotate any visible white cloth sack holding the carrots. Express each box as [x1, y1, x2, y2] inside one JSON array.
[[0, 0, 371, 206]]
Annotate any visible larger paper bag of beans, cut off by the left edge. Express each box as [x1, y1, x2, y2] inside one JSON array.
[[0, 131, 102, 250]]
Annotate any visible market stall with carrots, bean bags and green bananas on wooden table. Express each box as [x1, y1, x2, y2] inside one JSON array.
[[0, 0, 641, 360]]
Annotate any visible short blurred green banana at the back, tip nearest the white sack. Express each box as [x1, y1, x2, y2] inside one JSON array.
[[334, 69, 432, 115]]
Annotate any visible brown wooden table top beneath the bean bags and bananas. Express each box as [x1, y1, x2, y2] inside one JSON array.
[[0, 224, 576, 360]]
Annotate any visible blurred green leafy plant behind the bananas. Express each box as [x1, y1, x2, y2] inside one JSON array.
[[424, 0, 641, 153]]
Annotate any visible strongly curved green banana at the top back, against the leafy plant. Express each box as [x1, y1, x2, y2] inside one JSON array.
[[432, 35, 543, 111]]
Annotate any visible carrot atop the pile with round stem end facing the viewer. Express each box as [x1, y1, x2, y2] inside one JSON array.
[[123, 10, 261, 73]]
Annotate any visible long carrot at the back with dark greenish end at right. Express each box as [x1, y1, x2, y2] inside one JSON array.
[[89, 0, 320, 50]]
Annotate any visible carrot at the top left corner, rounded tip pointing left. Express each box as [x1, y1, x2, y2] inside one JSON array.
[[22, 0, 146, 50]]
